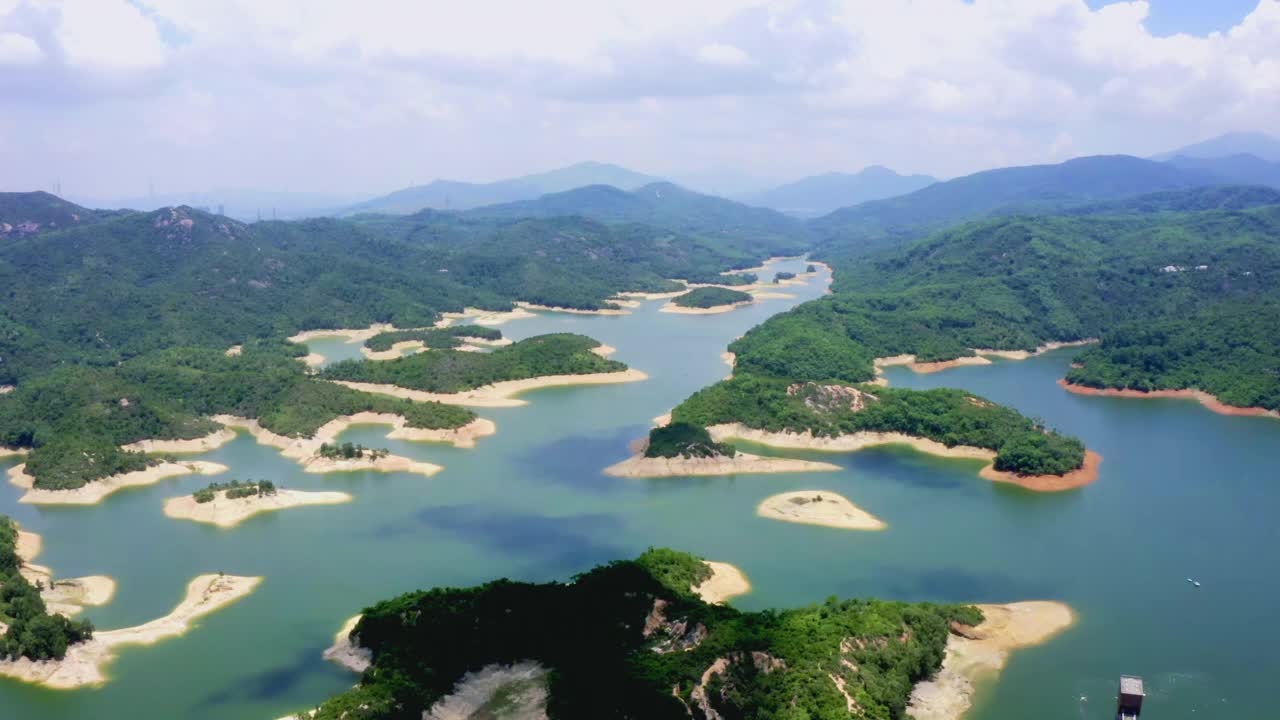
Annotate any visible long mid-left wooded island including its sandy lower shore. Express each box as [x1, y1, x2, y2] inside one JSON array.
[[321, 333, 648, 407]]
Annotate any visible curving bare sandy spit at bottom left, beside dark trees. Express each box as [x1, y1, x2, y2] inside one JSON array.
[[0, 575, 262, 689]]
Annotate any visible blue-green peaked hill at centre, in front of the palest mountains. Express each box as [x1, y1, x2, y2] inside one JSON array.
[[468, 182, 808, 255]]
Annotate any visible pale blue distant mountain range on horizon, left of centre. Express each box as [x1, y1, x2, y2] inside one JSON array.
[[339, 163, 662, 215]]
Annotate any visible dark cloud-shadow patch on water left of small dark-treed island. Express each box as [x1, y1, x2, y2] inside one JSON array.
[[516, 424, 649, 495]]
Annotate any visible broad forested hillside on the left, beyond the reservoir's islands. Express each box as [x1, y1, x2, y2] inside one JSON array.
[[0, 196, 776, 384]]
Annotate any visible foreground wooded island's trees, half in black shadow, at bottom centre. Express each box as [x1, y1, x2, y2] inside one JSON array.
[[294, 550, 983, 720]]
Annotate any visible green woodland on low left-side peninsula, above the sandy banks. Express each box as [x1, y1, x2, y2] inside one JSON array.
[[0, 342, 476, 489]]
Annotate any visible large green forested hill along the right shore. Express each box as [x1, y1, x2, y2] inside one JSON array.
[[730, 198, 1280, 409]]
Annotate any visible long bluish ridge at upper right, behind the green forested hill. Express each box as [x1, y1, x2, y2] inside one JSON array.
[[810, 155, 1224, 256]]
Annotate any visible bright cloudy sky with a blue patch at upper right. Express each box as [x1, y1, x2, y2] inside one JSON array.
[[0, 0, 1280, 199]]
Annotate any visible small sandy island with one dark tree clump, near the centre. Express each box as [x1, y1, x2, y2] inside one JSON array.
[[604, 423, 840, 478]]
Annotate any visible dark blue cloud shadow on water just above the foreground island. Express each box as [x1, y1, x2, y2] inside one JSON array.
[[399, 505, 626, 568]]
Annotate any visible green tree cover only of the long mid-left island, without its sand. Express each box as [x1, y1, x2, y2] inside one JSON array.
[[320, 333, 627, 393]]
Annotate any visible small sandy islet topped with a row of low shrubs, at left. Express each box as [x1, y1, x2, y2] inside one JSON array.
[[164, 480, 352, 528]]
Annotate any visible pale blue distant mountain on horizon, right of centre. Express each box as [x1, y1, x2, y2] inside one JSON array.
[[736, 165, 938, 218]]
